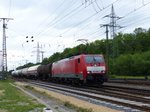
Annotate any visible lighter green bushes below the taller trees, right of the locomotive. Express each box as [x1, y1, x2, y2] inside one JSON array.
[[109, 51, 150, 76]]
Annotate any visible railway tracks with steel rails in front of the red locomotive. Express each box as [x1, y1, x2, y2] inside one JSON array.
[[23, 81, 150, 111]]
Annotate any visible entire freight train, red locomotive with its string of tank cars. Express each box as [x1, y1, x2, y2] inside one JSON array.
[[12, 54, 107, 84]]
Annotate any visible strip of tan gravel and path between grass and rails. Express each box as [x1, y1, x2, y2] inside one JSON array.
[[16, 82, 119, 112]]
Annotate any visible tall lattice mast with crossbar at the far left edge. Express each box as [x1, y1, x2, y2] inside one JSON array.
[[0, 18, 13, 72]]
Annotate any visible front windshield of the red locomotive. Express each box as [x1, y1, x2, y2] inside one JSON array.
[[85, 56, 104, 63]]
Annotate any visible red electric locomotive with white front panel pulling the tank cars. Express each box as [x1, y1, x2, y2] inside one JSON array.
[[52, 54, 107, 84]]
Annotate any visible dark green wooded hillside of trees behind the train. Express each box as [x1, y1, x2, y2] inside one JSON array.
[[15, 28, 150, 77]]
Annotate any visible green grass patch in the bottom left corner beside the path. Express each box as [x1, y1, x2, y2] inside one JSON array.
[[0, 80, 44, 112]]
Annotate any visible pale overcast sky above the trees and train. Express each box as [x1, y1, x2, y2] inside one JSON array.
[[0, 0, 150, 70]]
